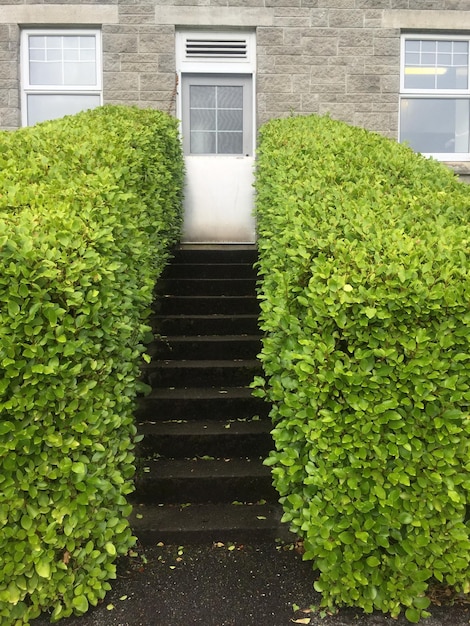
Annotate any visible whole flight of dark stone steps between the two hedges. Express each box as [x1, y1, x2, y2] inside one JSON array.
[[131, 246, 287, 544]]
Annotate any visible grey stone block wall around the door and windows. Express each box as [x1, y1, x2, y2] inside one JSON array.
[[0, 0, 470, 163]]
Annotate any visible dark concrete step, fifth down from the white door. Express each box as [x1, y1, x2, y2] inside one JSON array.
[[149, 314, 260, 335]]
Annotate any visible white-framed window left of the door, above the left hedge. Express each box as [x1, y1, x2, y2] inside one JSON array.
[[21, 30, 102, 126]]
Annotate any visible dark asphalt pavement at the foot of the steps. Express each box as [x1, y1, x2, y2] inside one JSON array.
[[31, 542, 470, 626]]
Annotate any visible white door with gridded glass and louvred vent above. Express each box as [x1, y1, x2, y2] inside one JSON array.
[[176, 32, 255, 243]]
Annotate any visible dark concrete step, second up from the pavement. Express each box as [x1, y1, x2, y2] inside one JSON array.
[[132, 458, 278, 504]]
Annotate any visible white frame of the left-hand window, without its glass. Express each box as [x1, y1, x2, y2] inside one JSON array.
[[21, 28, 103, 126]]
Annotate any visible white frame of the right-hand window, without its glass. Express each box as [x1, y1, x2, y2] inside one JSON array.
[[398, 32, 470, 161]]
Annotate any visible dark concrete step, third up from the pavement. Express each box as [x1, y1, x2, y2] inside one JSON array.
[[137, 419, 272, 459]]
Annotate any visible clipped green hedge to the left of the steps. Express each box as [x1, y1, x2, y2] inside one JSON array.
[[0, 106, 183, 626]]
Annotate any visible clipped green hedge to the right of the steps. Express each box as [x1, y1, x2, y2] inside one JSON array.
[[256, 117, 470, 622]]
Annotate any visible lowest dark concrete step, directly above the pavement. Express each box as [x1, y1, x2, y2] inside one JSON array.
[[130, 503, 293, 545]]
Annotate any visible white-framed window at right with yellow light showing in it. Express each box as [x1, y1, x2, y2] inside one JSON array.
[[400, 35, 470, 161]]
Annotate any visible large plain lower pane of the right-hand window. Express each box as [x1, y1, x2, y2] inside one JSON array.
[[400, 98, 470, 153]]
